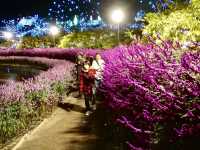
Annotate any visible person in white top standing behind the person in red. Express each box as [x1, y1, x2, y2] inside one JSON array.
[[91, 53, 105, 109]]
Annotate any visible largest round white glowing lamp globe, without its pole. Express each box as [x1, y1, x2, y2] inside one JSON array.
[[111, 9, 125, 24]]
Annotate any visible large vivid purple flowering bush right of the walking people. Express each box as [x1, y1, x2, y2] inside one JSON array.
[[101, 41, 200, 150]]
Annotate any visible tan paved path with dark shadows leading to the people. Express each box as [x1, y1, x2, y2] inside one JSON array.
[[13, 97, 115, 150]]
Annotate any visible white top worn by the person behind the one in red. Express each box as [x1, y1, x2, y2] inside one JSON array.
[[91, 59, 105, 80]]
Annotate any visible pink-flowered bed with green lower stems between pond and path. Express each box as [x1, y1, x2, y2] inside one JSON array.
[[0, 57, 74, 143]]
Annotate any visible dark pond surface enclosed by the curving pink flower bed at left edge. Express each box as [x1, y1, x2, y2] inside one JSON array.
[[0, 59, 49, 84]]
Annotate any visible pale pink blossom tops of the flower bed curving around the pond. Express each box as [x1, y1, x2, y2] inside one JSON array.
[[0, 57, 74, 105]]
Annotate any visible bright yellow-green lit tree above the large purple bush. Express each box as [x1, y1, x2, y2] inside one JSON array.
[[143, 0, 200, 42]]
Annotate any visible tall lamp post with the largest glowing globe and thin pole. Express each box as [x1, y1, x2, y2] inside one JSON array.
[[111, 9, 125, 43]]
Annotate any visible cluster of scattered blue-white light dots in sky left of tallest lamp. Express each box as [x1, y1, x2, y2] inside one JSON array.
[[49, 0, 100, 22]]
